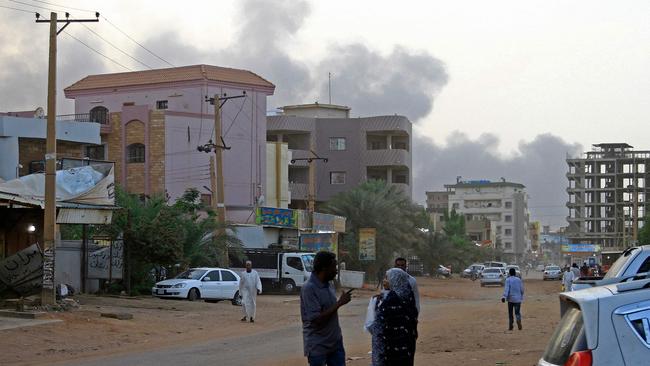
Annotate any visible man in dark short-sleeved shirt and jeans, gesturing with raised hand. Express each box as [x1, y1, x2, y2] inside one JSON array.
[[300, 252, 350, 366]]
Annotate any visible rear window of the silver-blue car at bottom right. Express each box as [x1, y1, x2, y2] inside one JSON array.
[[543, 307, 586, 365]]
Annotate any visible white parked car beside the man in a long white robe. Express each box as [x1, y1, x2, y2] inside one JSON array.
[[151, 268, 241, 305]]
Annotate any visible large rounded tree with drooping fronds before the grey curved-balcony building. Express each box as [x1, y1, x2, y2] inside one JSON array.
[[323, 180, 428, 269]]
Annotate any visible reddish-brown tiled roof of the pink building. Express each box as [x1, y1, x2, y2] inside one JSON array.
[[65, 65, 275, 94]]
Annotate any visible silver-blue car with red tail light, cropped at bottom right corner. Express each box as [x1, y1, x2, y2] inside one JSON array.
[[537, 279, 650, 366]]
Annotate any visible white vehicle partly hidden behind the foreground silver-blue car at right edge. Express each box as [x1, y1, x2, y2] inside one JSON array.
[[571, 245, 650, 291]]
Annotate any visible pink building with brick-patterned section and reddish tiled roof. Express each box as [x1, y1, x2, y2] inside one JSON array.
[[65, 65, 275, 223]]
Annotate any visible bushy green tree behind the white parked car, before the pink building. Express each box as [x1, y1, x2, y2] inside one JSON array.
[[102, 188, 240, 293]]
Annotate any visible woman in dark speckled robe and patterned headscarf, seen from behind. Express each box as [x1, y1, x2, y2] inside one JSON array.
[[368, 268, 418, 366]]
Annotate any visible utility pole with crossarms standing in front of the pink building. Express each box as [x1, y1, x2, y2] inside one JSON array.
[[197, 91, 246, 266]]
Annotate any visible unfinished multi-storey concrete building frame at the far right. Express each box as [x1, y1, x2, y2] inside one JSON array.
[[566, 143, 650, 250]]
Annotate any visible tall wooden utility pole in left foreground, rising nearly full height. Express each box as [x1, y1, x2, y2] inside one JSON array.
[[36, 12, 99, 305]]
